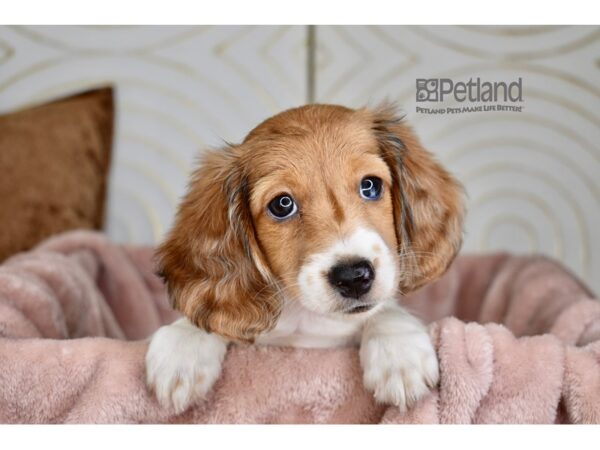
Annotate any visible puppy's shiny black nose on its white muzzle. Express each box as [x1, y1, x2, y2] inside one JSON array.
[[328, 259, 375, 298]]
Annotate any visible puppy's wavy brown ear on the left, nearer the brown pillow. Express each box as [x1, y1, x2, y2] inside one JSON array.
[[157, 147, 280, 342]]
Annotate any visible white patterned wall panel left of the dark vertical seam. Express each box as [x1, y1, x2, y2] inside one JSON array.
[[0, 26, 306, 243]]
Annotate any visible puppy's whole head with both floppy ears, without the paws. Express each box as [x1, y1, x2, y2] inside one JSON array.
[[158, 105, 463, 341]]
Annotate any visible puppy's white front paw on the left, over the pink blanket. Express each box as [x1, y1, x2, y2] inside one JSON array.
[[146, 319, 227, 414]]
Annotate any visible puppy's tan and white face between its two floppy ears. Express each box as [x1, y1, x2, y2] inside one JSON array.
[[246, 107, 398, 314]]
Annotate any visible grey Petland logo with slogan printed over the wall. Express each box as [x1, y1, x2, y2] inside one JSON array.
[[417, 77, 523, 114]]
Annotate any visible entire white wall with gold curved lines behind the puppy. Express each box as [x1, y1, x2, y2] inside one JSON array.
[[0, 26, 600, 291]]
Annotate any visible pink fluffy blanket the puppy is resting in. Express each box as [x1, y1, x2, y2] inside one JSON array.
[[0, 232, 600, 423]]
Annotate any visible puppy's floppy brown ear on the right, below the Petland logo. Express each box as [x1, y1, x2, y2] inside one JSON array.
[[373, 106, 464, 294]]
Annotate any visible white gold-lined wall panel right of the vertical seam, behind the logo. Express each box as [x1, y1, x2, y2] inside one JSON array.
[[315, 26, 600, 291]]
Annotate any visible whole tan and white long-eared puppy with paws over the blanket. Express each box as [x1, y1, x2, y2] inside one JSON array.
[[146, 105, 463, 412]]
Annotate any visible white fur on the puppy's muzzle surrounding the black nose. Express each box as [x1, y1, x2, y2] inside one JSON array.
[[298, 227, 396, 313]]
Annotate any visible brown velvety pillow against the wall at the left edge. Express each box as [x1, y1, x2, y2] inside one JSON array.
[[0, 88, 114, 261]]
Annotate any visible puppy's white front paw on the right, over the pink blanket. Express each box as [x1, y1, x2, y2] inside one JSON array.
[[360, 331, 439, 412]]
